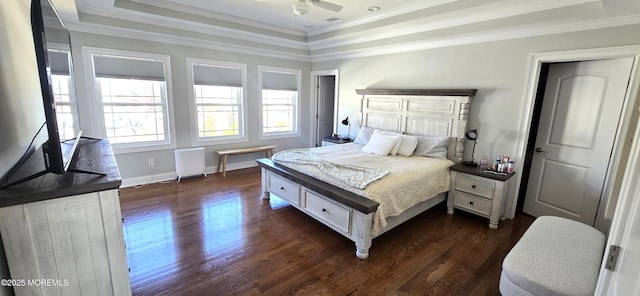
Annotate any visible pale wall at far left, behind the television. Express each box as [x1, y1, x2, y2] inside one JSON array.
[[0, 0, 46, 296]]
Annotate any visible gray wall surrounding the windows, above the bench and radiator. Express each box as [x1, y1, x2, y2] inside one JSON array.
[[71, 32, 312, 185]]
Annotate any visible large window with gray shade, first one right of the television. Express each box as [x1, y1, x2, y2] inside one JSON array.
[[85, 48, 173, 152]]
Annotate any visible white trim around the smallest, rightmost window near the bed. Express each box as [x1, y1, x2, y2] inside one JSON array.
[[258, 65, 302, 140]]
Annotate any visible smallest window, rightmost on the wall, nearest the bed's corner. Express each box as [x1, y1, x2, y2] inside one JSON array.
[[259, 66, 301, 138]]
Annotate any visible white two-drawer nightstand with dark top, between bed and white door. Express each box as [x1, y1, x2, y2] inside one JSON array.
[[447, 163, 515, 229]]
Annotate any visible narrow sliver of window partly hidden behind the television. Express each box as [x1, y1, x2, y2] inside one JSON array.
[[48, 49, 77, 140]]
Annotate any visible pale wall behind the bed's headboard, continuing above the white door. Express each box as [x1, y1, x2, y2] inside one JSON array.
[[313, 25, 640, 225]]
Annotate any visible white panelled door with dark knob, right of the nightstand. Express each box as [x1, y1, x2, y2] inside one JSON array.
[[524, 58, 633, 225]]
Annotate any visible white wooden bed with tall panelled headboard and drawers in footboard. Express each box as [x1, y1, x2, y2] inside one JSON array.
[[257, 89, 476, 259]]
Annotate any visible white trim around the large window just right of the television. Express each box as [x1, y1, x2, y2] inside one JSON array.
[[82, 46, 177, 154]]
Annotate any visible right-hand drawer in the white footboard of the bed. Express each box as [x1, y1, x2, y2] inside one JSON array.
[[304, 190, 351, 233]]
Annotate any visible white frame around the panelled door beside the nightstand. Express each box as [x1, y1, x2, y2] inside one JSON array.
[[506, 45, 640, 233]]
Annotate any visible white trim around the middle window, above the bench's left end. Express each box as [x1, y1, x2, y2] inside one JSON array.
[[187, 57, 249, 146]]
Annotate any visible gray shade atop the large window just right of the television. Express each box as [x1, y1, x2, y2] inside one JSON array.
[[93, 56, 165, 81]]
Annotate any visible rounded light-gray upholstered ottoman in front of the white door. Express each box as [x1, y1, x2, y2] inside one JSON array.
[[500, 216, 605, 296]]
